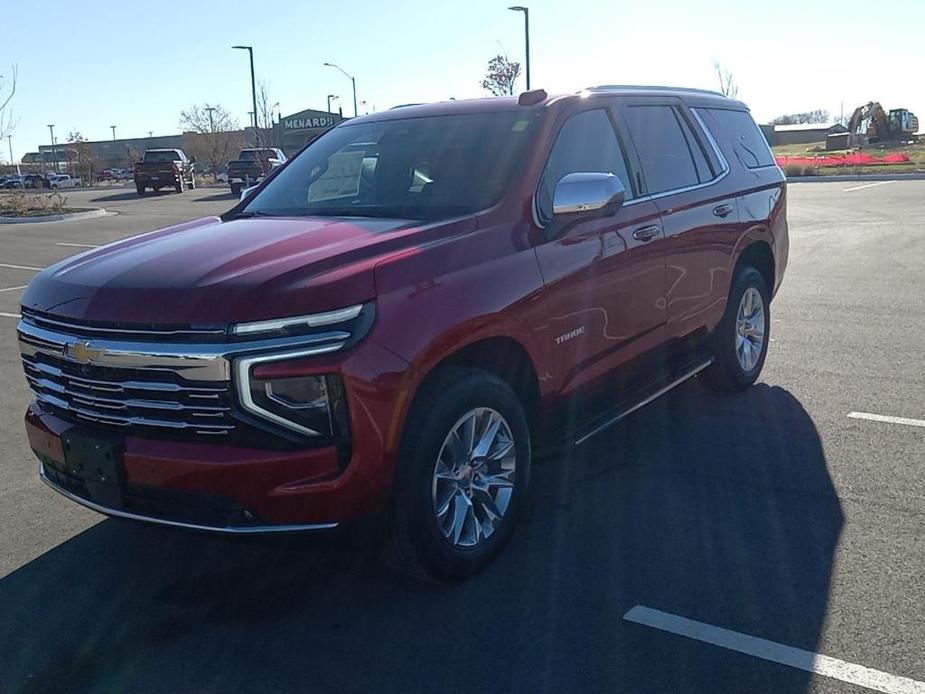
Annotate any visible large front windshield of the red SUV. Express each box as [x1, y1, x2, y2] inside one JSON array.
[[244, 111, 537, 219]]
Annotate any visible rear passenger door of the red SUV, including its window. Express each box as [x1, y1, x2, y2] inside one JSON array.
[[621, 98, 742, 339]]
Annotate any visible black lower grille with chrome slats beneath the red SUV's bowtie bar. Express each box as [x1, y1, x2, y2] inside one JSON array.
[[22, 352, 235, 436]]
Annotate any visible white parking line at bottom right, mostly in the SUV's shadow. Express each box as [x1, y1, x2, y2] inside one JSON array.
[[623, 605, 925, 694]]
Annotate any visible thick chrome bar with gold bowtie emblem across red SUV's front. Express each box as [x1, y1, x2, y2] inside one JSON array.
[[17, 321, 350, 382]]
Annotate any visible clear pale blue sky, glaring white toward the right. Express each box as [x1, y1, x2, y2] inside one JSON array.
[[0, 0, 925, 160]]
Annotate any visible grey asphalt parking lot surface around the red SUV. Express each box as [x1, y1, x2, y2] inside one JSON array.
[[0, 181, 925, 694]]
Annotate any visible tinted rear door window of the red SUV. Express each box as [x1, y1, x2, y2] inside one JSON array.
[[624, 106, 703, 193]]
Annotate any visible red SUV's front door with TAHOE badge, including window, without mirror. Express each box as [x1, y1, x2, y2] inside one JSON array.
[[536, 106, 666, 392]]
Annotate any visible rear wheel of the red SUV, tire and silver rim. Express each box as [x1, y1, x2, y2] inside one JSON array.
[[703, 265, 771, 393]]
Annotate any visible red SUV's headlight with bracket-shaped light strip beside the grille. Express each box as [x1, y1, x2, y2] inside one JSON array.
[[236, 352, 349, 441]]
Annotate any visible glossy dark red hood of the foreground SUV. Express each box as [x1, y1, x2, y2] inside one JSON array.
[[22, 217, 430, 325]]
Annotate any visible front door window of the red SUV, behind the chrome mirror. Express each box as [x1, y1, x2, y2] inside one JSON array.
[[539, 109, 633, 218]]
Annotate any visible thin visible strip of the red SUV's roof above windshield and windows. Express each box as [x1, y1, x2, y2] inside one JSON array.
[[344, 85, 748, 125]]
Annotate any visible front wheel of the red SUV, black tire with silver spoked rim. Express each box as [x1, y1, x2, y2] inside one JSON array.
[[390, 369, 531, 581]]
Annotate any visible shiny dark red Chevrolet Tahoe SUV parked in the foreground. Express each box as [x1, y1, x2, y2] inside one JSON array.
[[18, 87, 788, 580]]
